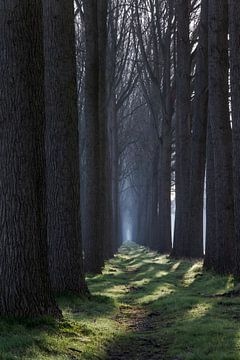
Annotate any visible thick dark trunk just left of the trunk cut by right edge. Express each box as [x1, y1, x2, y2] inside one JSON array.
[[209, 0, 234, 273]]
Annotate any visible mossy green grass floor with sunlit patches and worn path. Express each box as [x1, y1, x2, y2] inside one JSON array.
[[0, 245, 240, 360]]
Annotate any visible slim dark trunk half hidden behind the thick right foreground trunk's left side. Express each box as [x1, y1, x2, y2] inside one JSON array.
[[204, 123, 218, 270]]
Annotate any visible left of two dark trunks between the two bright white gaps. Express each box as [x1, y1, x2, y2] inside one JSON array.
[[172, 0, 191, 257]]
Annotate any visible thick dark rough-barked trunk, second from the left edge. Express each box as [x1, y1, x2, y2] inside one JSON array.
[[43, 0, 86, 294]]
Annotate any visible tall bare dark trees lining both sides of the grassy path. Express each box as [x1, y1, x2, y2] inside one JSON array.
[[0, 0, 240, 317]]
